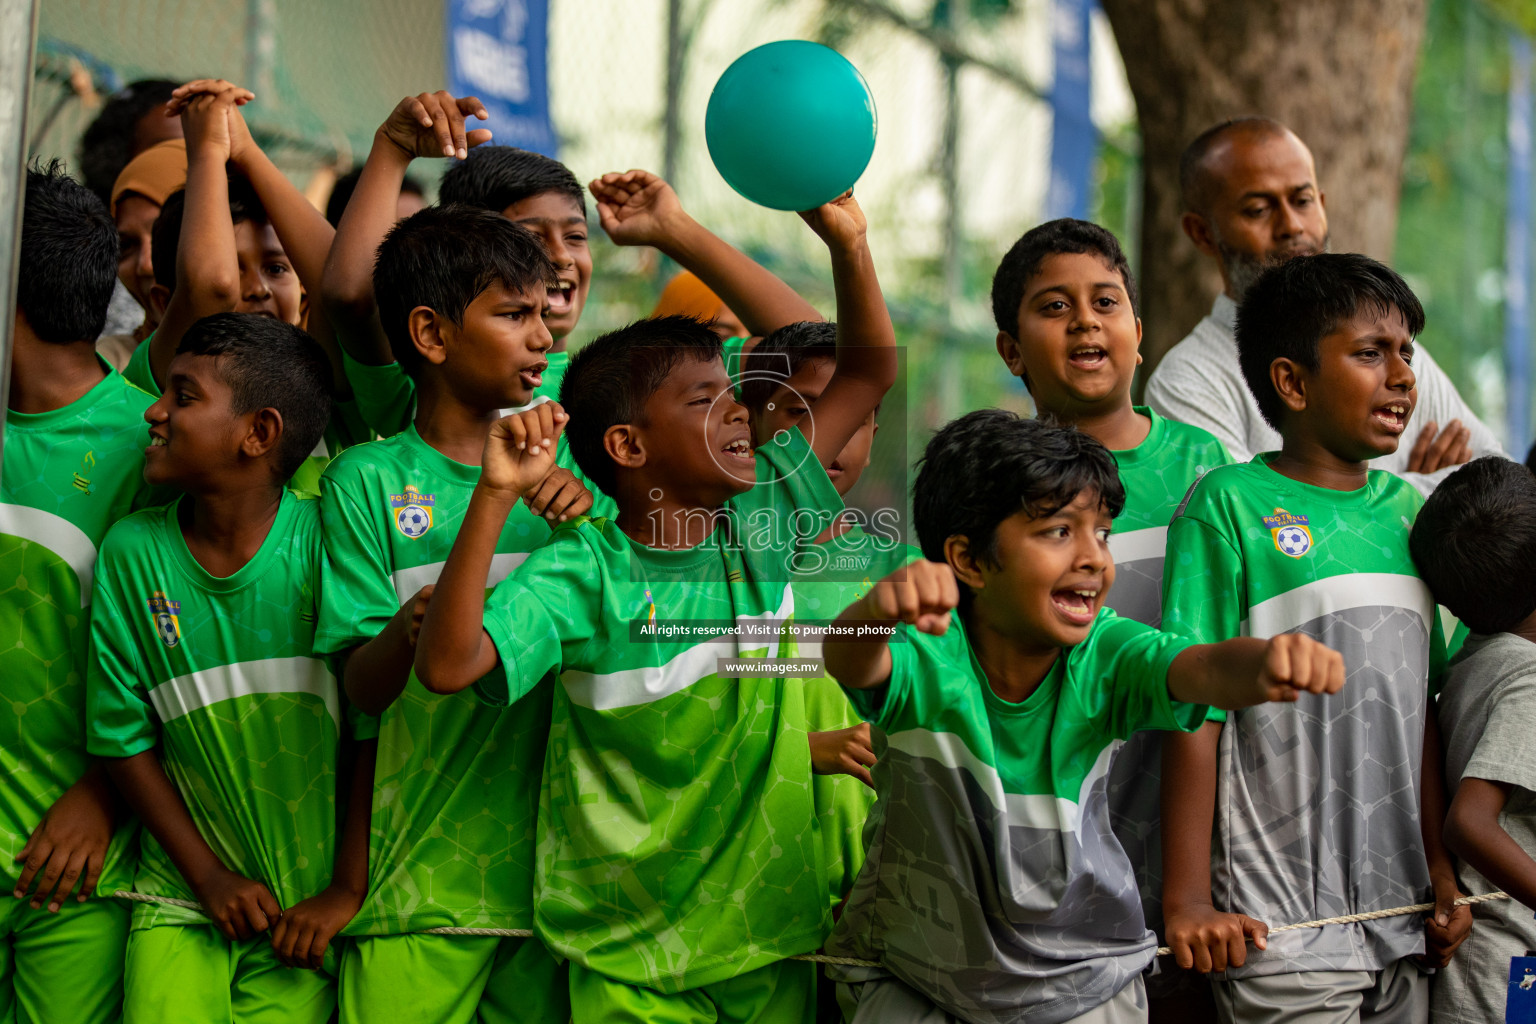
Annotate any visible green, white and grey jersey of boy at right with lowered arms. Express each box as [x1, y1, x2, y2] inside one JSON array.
[[1163, 454, 1445, 976]]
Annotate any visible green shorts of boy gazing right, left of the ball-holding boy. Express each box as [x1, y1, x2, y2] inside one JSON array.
[[339, 935, 570, 1024]]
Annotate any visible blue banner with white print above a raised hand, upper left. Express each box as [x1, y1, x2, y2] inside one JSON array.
[[445, 0, 556, 157]]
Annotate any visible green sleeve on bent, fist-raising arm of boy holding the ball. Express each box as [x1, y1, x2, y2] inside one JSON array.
[[475, 522, 604, 705]]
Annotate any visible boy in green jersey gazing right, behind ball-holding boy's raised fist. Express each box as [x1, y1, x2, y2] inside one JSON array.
[[316, 206, 591, 1024]]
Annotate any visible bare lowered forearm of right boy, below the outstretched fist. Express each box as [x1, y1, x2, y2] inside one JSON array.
[[1163, 722, 1221, 907]]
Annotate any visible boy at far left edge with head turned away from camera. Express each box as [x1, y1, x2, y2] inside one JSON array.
[[0, 164, 152, 1024]]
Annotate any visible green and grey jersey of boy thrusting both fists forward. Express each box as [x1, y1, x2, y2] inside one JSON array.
[[826, 608, 1206, 1024]]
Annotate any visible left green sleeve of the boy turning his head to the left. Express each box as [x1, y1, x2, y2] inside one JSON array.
[[86, 574, 160, 757]]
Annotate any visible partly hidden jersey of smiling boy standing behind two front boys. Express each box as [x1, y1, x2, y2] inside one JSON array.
[[1104, 405, 1232, 951]]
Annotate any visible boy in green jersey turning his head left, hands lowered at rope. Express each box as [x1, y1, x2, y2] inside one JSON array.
[[86, 313, 341, 1024]]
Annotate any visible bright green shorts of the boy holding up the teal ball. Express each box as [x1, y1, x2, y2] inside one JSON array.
[[570, 960, 816, 1024]]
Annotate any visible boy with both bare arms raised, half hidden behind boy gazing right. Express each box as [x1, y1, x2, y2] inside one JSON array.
[[324, 92, 817, 439]]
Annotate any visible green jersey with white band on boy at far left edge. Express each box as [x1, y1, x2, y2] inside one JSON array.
[[0, 364, 154, 892]]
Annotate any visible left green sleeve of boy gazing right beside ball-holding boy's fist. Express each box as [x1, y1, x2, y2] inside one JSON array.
[[315, 464, 401, 654]]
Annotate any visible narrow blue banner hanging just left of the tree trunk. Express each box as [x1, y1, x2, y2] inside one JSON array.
[[1046, 0, 1098, 220]]
